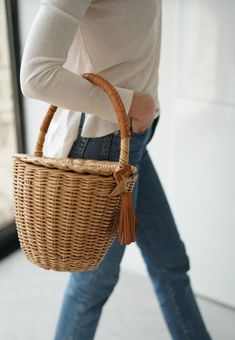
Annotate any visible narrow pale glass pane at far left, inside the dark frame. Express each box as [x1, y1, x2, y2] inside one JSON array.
[[0, 0, 16, 229]]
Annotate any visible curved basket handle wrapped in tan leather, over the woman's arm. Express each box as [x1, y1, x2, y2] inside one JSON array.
[[34, 73, 131, 166]]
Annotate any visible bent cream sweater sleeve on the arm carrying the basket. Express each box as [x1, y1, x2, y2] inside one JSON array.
[[20, 0, 134, 123]]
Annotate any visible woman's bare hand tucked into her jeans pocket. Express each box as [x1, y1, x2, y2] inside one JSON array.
[[128, 91, 157, 132]]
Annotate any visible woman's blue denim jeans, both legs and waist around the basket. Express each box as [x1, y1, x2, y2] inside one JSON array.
[[54, 117, 211, 340]]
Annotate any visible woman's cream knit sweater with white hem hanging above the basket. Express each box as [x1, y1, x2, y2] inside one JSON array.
[[20, 0, 161, 157]]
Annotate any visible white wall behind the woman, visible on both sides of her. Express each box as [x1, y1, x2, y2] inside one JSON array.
[[20, 0, 235, 306]]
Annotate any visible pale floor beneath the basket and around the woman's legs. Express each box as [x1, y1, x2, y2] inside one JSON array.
[[0, 250, 235, 340]]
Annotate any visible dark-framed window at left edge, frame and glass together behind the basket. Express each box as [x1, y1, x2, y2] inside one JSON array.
[[0, 0, 24, 257]]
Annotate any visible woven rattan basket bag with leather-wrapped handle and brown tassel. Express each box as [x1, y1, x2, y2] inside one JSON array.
[[13, 73, 137, 272]]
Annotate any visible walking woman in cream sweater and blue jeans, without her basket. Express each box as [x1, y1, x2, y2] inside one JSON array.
[[20, 0, 210, 340]]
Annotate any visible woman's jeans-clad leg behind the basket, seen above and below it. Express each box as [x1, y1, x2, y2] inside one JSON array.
[[54, 134, 125, 340]]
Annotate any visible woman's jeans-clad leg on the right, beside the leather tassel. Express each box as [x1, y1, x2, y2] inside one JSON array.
[[136, 151, 211, 340]]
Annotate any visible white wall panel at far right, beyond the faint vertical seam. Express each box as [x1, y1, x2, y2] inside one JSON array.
[[166, 0, 235, 306]]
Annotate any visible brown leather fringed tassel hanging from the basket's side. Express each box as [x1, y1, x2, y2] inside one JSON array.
[[117, 192, 137, 244]]
